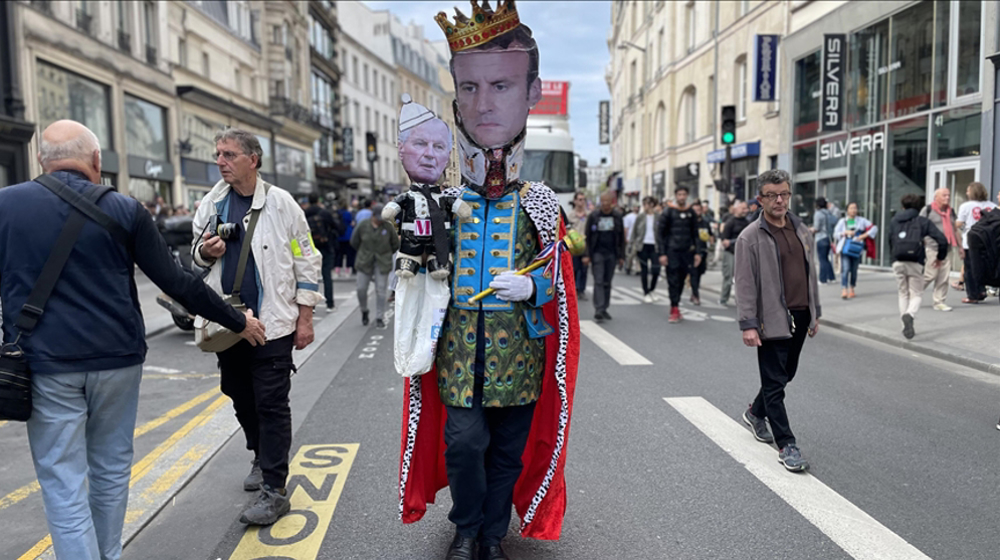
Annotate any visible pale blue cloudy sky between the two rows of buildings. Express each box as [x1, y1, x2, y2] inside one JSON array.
[[365, 0, 611, 165]]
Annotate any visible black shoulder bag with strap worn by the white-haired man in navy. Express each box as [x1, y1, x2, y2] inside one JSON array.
[[0, 175, 122, 422]]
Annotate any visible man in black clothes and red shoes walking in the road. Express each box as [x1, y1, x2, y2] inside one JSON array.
[[656, 186, 701, 323]]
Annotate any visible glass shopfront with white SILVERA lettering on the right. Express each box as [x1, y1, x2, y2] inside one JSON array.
[[791, 1, 983, 266]]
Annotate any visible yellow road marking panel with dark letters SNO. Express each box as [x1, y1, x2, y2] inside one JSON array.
[[229, 443, 360, 560]]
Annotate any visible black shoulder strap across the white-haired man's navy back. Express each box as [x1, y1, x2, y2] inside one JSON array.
[[16, 183, 114, 336]]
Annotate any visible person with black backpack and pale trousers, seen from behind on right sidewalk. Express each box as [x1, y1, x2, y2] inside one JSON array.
[[889, 194, 948, 339]]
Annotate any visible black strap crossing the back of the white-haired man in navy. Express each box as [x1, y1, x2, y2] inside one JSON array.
[[15, 175, 117, 336]]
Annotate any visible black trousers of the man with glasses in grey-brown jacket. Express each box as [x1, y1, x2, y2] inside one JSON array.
[[750, 309, 810, 449]]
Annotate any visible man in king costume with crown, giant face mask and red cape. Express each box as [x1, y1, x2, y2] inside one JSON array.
[[399, 0, 580, 560]]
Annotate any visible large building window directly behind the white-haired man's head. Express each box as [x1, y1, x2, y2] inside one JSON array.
[[36, 60, 113, 150]]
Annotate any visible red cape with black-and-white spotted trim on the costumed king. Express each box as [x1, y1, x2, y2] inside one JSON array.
[[399, 183, 580, 540]]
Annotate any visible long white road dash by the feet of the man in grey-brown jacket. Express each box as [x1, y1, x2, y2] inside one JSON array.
[[663, 397, 930, 560]]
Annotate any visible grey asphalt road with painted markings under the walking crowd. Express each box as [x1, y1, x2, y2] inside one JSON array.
[[0, 275, 1000, 560]]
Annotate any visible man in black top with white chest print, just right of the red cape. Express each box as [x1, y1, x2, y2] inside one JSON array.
[[583, 191, 625, 323]]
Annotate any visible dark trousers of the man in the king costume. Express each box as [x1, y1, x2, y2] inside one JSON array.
[[444, 312, 540, 546]]
